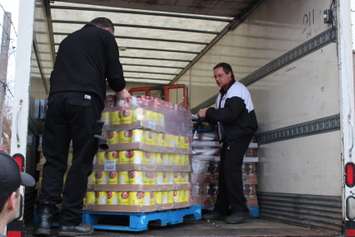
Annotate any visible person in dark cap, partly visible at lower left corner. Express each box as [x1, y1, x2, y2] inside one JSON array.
[[0, 152, 35, 237]]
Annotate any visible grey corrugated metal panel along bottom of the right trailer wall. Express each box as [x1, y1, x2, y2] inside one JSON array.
[[258, 192, 342, 233]]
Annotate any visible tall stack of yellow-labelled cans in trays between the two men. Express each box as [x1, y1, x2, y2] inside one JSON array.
[[85, 96, 192, 213]]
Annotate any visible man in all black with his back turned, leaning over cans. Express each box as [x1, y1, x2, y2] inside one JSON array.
[[35, 17, 130, 236]]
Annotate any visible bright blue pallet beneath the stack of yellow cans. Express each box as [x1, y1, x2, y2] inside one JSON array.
[[83, 205, 201, 232]]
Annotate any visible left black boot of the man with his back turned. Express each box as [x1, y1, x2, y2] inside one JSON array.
[[34, 206, 59, 236]]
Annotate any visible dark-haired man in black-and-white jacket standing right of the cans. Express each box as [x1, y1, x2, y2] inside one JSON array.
[[198, 63, 257, 224]]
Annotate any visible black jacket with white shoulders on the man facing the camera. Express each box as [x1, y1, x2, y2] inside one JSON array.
[[206, 82, 258, 142]]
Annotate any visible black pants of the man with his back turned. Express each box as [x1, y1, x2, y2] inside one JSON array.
[[39, 92, 102, 225]]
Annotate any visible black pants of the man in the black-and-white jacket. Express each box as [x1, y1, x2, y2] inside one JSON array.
[[215, 136, 252, 214]]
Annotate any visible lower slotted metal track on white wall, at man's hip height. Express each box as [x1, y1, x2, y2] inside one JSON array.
[[256, 114, 340, 145]]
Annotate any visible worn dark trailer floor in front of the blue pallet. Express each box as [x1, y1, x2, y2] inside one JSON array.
[[26, 219, 340, 237]]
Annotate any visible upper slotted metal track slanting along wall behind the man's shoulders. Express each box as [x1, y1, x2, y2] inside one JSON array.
[[191, 27, 337, 113]]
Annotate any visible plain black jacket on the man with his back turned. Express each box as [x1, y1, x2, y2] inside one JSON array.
[[50, 24, 125, 105]]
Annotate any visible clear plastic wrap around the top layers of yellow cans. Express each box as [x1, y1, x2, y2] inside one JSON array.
[[101, 96, 192, 137]]
